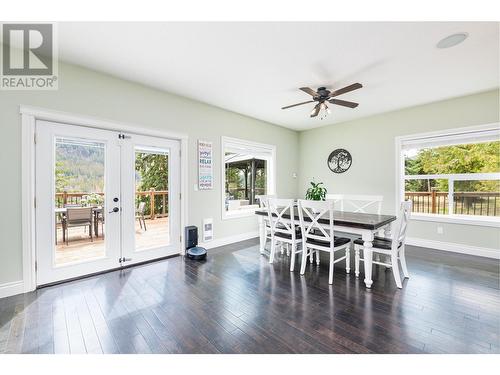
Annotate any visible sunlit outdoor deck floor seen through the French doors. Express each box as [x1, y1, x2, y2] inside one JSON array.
[[56, 217, 169, 265]]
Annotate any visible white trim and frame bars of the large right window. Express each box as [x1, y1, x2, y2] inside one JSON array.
[[395, 122, 500, 228]]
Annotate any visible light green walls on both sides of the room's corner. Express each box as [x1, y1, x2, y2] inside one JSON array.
[[0, 64, 500, 284]]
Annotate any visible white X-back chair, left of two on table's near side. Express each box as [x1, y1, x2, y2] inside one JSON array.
[[267, 198, 302, 272]]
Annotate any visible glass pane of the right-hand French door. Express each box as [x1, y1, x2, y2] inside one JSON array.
[[135, 146, 170, 251]]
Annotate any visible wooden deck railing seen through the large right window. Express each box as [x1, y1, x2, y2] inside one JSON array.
[[405, 191, 500, 216]]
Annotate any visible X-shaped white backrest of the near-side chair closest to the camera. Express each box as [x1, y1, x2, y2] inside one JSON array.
[[297, 199, 334, 248]]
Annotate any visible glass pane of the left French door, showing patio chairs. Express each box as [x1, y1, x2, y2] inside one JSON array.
[[54, 138, 105, 266]]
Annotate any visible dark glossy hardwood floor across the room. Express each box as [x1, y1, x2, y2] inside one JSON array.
[[0, 240, 500, 353]]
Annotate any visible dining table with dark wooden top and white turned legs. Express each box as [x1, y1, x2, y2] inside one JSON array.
[[255, 207, 396, 288]]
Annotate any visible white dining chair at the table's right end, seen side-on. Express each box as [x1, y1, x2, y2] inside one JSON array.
[[354, 201, 412, 288]]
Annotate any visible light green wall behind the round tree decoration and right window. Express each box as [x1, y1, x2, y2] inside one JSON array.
[[298, 90, 500, 249]]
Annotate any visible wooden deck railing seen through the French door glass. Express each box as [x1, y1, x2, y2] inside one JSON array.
[[56, 189, 168, 219]]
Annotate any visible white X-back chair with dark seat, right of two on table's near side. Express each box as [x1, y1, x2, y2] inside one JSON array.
[[298, 199, 351, 284]]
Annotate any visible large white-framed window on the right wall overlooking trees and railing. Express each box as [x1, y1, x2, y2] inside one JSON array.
[[397, 124, 500, 226]]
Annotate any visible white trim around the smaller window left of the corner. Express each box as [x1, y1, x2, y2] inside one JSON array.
[[220, 136, 276, 220]]
